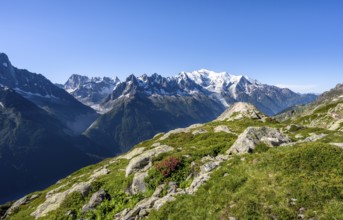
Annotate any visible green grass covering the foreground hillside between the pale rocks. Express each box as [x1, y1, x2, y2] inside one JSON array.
[[6, 116, 343, 219]]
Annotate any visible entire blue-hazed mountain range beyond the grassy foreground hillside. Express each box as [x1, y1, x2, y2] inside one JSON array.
[[0, 53, 316, 205]]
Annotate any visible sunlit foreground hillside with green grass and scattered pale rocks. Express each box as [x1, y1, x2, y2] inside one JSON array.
[[5, 100, 343, 219]]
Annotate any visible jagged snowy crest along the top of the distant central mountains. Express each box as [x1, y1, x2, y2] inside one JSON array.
[[64, 69, 316, 115]]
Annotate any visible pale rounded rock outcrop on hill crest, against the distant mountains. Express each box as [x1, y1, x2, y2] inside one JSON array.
[[217, 102, 267, 121]]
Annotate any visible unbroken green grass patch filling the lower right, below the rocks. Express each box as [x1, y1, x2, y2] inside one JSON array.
[[149, 143, 343, 219]]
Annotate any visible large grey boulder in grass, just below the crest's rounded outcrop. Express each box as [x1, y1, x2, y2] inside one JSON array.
[[227, 127, 291, 154]]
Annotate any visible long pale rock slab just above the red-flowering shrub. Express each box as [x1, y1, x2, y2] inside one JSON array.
[[126, 145, 174, 177]]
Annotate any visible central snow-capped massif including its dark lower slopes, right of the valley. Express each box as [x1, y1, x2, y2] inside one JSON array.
[[64, 69, 316, 153]]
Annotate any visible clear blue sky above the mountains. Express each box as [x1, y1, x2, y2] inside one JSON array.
[[0, 0, 343, 93]]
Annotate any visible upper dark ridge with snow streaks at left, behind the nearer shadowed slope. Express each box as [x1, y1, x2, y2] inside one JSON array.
[[0, 53, 97, 135]]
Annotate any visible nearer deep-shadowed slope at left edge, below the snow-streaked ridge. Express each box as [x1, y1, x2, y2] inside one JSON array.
[[0, 86, 99, 202]]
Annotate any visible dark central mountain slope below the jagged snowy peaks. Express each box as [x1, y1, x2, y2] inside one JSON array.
[[85, 75, 224, 153]]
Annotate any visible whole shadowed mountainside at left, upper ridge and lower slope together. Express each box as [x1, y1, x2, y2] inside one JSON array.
[[0, 53, 109, 203]]
